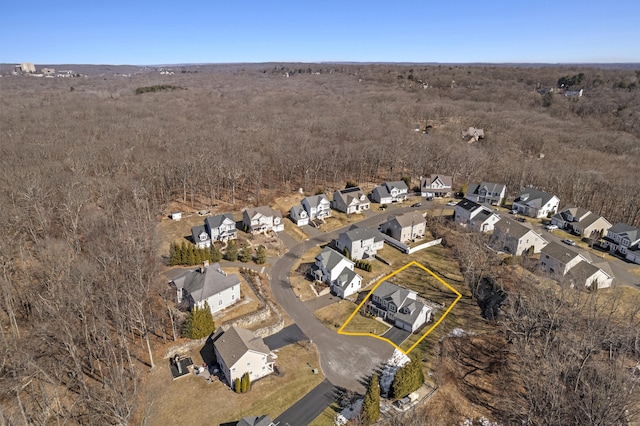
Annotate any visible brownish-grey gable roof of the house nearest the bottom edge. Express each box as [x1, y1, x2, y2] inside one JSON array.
[[211, 326, 271, 368]]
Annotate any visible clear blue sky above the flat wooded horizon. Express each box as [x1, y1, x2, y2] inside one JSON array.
[[0, 0, 640, 65]]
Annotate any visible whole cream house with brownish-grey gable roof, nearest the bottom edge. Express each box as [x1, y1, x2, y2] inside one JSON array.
[[211, 326, 275, 386]]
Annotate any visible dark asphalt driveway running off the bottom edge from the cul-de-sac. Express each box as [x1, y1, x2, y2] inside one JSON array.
[[274, 380, 338, 426]]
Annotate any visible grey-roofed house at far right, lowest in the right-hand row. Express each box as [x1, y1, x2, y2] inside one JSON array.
[[540, 241, 613, 288]]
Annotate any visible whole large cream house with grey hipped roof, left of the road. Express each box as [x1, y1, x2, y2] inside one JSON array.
[[170, 262, 240, 314]]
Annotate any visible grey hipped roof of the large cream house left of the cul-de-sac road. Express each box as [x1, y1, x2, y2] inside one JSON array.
[[173, 263, 240, 303]]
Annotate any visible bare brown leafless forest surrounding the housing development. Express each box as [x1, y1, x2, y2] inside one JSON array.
[[0, 64, 640, 425]]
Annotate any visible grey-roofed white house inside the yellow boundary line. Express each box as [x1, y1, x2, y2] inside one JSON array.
[[367, 281, 434, 333]]
